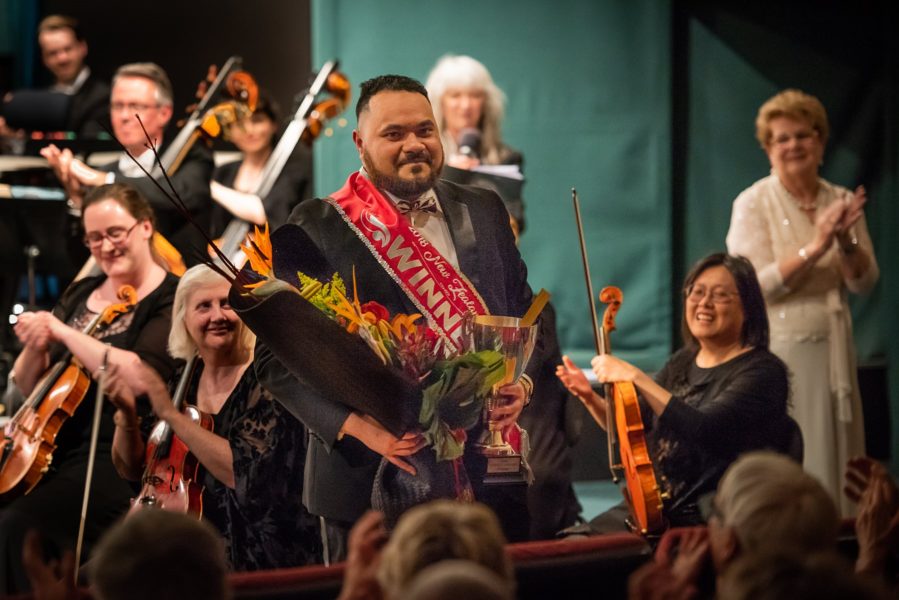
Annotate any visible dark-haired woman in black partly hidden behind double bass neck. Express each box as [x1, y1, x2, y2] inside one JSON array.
[[210, 95, 309, 236]]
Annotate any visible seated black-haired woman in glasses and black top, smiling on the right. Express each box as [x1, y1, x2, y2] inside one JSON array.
[[556, 254, 790, 532]]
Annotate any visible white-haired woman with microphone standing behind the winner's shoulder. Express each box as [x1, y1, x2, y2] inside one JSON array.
[[425, 54, 524, 236]]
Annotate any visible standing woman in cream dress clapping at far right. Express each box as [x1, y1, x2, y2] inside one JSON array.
[[727, 90, 879, 516]]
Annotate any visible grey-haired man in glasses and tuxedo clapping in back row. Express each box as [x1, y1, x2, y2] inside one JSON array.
[[41, 63, 215, 266]]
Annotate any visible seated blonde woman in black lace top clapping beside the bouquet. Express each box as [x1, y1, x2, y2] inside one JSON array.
[[109, 265, 318, 571]]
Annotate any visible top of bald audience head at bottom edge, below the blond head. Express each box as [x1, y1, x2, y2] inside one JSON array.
[[401, 560, 515, 600]]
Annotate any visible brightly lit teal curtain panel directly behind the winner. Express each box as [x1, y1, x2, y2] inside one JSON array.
[[312, 0, 671, 369]]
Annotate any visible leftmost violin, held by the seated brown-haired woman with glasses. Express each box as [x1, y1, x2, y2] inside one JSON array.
[[0, 285, 137, 498]]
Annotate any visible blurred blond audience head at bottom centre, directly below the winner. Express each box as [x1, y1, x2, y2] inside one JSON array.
[[378, 500, 514, 599]]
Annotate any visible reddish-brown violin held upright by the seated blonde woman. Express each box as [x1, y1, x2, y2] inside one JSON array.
[[128, 355, 213, 519]]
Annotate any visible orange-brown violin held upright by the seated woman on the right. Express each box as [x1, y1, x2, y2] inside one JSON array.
[[599, 286, 665, 535]]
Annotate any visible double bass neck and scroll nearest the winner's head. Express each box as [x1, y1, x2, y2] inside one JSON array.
[[209, 60, 351, 266]]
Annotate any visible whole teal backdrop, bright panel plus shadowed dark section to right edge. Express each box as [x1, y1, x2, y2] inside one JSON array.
[[312, 0, 899, 467]]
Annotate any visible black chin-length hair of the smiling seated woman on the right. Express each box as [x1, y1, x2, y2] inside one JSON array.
[[681, 252, 769, 350]]
